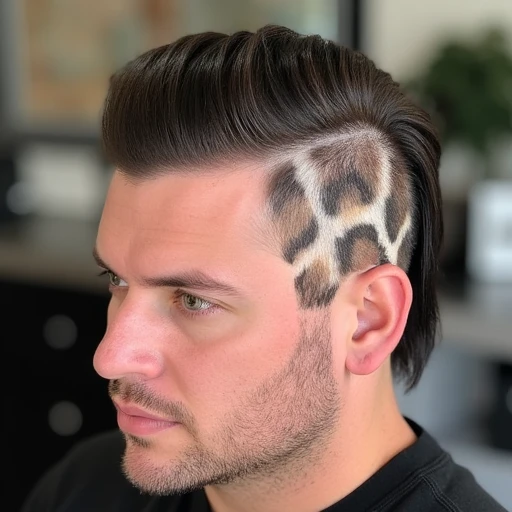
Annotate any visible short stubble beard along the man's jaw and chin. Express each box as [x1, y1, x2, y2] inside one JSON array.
[[115, 320, 342, 495]]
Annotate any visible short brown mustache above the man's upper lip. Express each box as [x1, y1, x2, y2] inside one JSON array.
[[108, 379, 194, 428]]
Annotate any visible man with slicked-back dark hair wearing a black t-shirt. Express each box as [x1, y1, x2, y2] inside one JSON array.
[[24, 26, 504, 512]]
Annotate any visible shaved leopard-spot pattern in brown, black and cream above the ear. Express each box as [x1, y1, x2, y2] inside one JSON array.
[[269, 129, 415, 308]]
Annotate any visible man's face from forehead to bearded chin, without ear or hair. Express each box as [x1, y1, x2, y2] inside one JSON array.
[[94, 169, 348, 493]]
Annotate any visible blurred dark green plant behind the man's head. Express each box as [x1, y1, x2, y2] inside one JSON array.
[[406, 28, 512, 166]]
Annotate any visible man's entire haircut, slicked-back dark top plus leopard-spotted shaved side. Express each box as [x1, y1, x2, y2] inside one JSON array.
[[102, 25, 443, 389]]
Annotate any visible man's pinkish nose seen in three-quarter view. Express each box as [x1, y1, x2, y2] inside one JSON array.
[[93, 296, 168, 380]]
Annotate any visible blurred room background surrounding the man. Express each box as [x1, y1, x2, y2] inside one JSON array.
[[0, 0, 512, 510]]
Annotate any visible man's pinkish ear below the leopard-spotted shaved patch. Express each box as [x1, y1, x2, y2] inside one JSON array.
[[345, 264, 412, 375]]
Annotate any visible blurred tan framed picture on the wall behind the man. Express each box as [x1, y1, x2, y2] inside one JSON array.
[[0, 0, 179, 138]]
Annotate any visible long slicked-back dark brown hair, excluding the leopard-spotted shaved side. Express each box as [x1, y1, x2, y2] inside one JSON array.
[[102, 26, 443, 388]]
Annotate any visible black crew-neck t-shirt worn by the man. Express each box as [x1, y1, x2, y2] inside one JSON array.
[[22, 422, 507, 512]]
